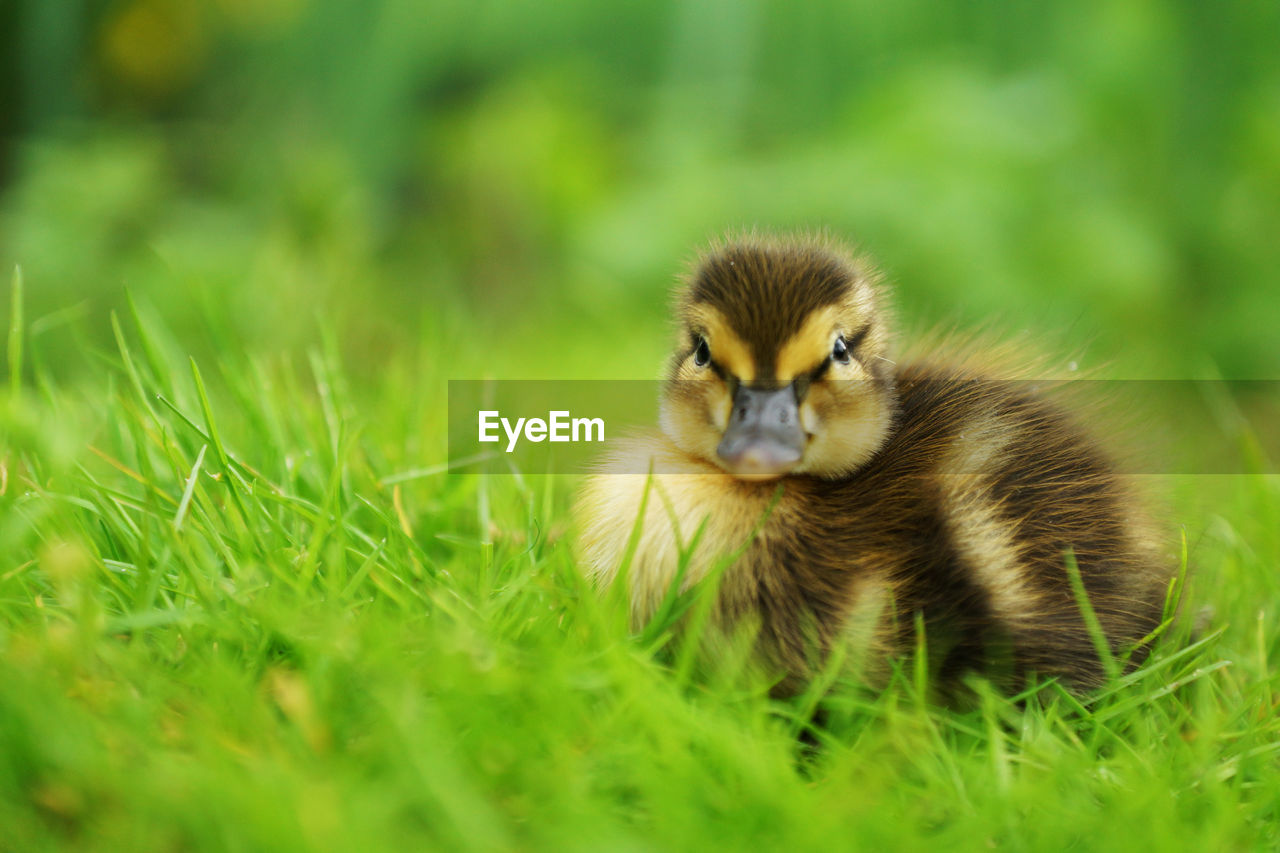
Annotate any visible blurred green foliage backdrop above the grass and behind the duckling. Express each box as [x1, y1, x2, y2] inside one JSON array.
[[0, 0, 1280, 384]]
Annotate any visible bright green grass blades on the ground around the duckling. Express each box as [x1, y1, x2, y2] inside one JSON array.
[[0, 280, 1280, 850]]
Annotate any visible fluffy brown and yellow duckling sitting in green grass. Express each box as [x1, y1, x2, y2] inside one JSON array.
[[576, 230, 1170, 695]]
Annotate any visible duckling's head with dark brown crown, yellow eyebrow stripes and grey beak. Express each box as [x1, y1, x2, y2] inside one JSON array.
[[660, 240, 895, 480]]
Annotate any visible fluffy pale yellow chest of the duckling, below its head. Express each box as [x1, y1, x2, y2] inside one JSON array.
[[577, 435, 777, 625]]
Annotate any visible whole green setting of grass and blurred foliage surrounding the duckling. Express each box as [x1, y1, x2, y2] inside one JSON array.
[[0, 0, 1280, 853]]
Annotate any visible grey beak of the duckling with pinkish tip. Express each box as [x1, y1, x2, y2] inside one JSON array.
[[716, 386, 805, 480]]
